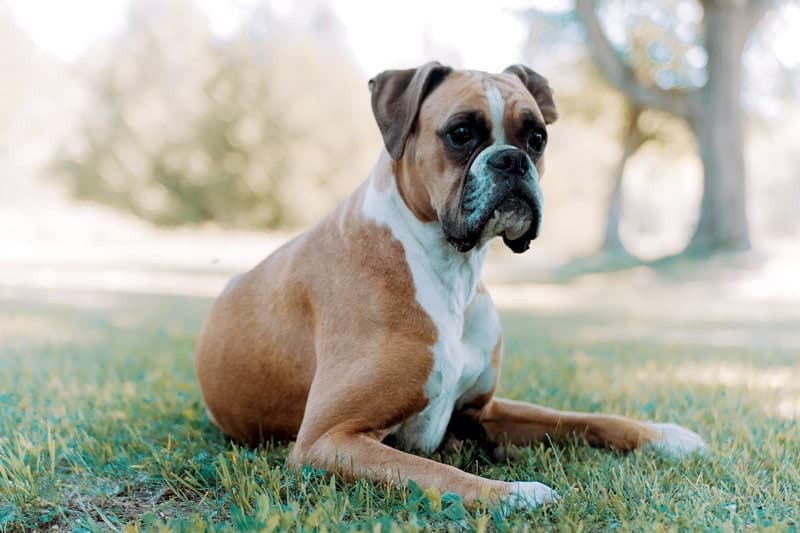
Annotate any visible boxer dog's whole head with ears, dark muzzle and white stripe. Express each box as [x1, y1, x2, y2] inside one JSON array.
[[370, 63, 557, 253]]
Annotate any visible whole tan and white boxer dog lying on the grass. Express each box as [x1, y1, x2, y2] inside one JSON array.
[[196, 62, 704, 507]]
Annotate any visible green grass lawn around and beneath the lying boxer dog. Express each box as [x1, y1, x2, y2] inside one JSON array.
[[0, 284, 800, 531]]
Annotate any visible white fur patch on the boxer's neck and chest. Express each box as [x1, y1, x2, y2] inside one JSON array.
[[362, 171, 500, 453]]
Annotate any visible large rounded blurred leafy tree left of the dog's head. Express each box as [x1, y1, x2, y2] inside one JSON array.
[[56, 0, 374, 228]]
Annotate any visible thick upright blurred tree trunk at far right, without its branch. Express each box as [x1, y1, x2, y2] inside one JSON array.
[[686, 0, 750, 253]]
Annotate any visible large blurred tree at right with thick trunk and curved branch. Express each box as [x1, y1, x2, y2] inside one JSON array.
[[576, 0, 772, 252]]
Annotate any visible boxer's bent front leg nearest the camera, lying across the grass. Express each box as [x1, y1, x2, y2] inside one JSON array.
[[289, 429, 557, 507]]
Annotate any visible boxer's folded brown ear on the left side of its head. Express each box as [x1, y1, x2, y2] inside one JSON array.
[[369, 61, 452, 160]]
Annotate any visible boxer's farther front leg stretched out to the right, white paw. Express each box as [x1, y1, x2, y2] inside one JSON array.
[[466, 398, 705, 456]]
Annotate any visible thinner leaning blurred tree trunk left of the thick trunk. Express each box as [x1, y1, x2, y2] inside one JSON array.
[[599, 106, 644, 255]]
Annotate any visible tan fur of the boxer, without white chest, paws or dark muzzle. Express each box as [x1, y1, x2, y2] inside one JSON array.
[[196, 63, 704, 508]]
